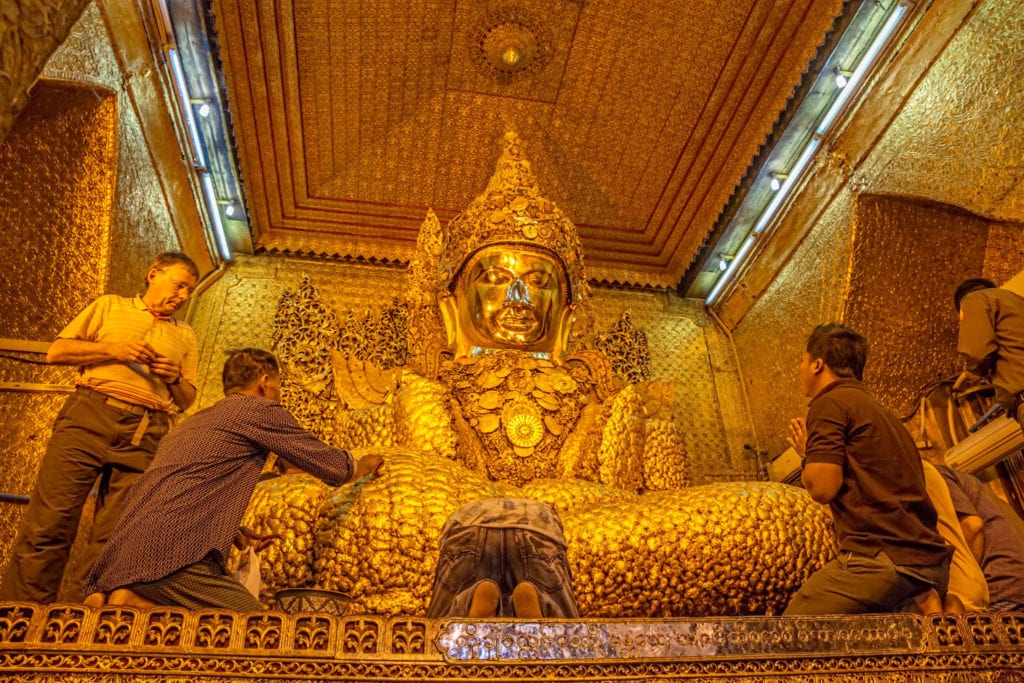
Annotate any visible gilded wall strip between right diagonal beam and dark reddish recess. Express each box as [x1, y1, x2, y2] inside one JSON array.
[[733, 187, 856, 456]]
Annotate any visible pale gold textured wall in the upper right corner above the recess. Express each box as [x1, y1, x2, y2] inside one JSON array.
[[858, 0, 1024, 221]]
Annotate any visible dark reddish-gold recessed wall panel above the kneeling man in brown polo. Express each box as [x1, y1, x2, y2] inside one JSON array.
[[846, 196, 988, 416]]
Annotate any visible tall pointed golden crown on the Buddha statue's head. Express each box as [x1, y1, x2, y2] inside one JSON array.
[[438, 132, 588, 302]]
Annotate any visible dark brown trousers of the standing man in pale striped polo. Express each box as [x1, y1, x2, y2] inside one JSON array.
[[0, 389, 169, 603]]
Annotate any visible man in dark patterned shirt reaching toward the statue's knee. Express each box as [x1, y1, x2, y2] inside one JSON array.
[[86, 348, 383, 611]]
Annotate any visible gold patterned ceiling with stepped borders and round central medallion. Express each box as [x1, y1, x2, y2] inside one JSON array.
[[213, 0, 843, 287]]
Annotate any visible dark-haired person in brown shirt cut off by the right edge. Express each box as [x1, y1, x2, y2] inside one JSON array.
[[953, 278, 1024, 424]]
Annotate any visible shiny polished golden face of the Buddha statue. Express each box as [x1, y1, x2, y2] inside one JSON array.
[[453, 245, 566, 352]]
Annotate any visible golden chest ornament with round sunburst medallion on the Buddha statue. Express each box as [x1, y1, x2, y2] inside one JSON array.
[[441, 350, 594, 485]]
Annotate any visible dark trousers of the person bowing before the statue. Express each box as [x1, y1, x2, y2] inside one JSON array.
[[427, 526, 580, 618]]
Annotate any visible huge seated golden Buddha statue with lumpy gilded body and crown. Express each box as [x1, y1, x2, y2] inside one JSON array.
[[246, 134, 835, 617]]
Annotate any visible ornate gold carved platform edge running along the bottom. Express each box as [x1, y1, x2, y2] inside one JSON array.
[[0, 603, 1024, 683]]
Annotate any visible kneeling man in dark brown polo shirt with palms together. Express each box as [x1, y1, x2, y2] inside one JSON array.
[[783, 325, 950, 615]]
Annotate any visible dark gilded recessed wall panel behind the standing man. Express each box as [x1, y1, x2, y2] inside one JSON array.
[[0, 83, 117, 339]]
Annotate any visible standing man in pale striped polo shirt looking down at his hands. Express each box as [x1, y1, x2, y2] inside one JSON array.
[[0, 252, 199, 603]]
